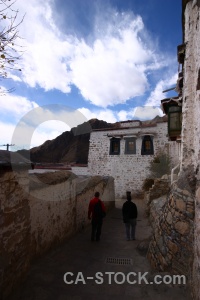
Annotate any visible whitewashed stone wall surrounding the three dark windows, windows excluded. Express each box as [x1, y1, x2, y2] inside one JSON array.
[[88, 122, 174, 198]]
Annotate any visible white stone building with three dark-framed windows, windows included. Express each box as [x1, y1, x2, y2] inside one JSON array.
[[88, 116, 178, 198]]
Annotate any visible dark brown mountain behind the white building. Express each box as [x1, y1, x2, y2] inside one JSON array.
[[17, 119, 117, 164]]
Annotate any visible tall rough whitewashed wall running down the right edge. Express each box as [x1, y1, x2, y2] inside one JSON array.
[[181, 0, 200, 299]]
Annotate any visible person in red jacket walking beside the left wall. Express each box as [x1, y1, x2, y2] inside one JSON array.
[[88, 192, 106, 242]]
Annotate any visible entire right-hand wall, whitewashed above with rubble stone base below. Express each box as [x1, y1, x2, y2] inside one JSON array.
[[148, 0, 200, 300]]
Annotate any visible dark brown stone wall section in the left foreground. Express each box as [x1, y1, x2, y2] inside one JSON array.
[[0, 171, 31, 299]]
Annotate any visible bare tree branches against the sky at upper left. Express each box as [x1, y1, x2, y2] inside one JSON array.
[[0, 0, 24, 95]]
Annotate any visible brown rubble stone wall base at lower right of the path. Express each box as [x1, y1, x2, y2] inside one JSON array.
[[147, 180, 194, 277]]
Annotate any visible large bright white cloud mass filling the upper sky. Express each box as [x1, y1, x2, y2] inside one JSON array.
[[10, 0, 171, 107]]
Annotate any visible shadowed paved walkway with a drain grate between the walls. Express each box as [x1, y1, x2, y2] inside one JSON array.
[[9, 202, 191, 300]]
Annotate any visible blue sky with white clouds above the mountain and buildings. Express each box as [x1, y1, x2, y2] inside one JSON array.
[[0, 0, 182, 151]]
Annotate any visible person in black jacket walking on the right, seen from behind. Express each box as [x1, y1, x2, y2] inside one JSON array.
[[122, 192, 138, 241]]
